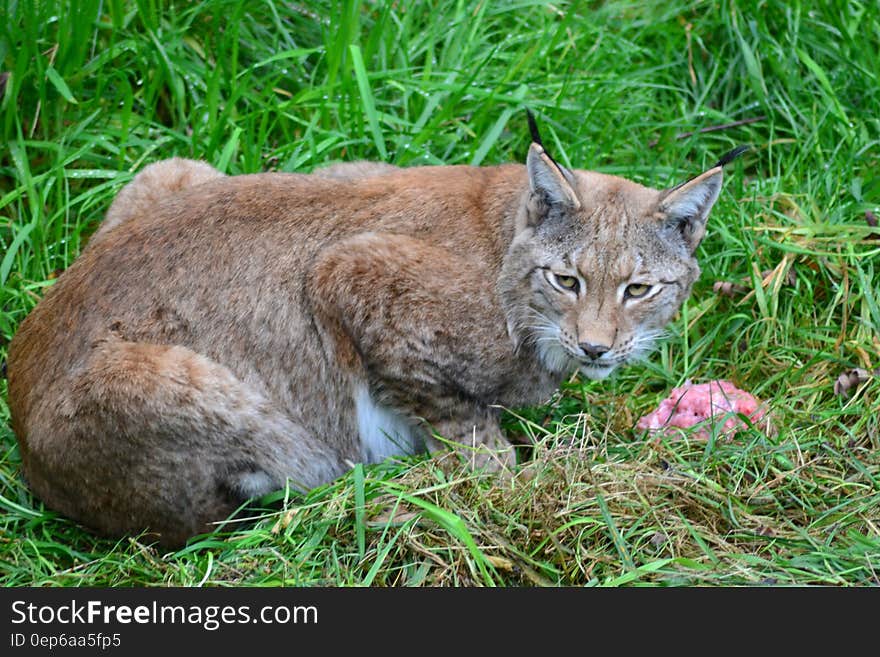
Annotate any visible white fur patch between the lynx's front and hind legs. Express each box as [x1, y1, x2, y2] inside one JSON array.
[[354, 385, 424, 463]]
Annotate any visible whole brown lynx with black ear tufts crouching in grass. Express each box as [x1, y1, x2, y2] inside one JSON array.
[[9, 116, 744, 545]]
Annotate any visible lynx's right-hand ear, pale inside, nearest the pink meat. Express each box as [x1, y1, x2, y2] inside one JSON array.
[[660, 166, 723, 253]]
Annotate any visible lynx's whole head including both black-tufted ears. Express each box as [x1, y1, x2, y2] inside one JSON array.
[[499, 120, 744, 379]]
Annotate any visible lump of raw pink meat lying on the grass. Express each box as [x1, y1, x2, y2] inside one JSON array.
[[636, 381, 767, 439]]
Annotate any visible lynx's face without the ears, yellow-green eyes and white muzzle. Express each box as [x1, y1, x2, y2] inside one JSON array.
[[512, 204, 699, 379]]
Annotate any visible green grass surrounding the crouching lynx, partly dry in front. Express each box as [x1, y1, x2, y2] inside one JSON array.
[[0, 0, 880, 586]]
